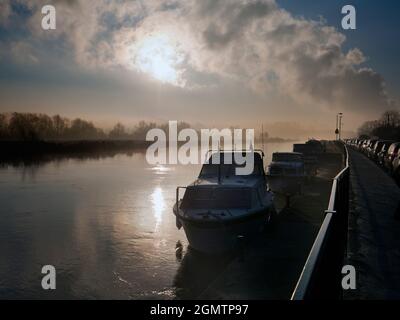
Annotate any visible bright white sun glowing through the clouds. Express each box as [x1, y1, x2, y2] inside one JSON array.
[[134, 35, 183, 86]]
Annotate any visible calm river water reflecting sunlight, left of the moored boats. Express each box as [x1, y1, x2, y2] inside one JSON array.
[[0, 143, 292, 299]]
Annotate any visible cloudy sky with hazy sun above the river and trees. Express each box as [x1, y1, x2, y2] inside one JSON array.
[[0, 0, 400, 138]]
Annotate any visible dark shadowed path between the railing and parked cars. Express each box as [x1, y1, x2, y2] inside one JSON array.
[[344, 150, 400, 299]]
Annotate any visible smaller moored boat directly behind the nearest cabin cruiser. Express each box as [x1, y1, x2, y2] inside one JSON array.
[[267, 152, 305, 195]]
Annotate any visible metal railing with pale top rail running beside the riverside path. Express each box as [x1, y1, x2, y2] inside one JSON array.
[[291, 145, 350, 300]]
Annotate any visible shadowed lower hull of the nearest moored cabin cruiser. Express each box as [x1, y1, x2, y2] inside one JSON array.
[[177, 209, 271, 254]]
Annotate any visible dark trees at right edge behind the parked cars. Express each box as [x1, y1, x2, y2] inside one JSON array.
[[358, 110, 400, 141]]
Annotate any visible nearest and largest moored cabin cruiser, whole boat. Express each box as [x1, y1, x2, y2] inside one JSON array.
[[174, 151, 274, 253]]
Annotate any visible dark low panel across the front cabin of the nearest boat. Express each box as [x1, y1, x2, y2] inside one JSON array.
[[182, 188, 251, 209]]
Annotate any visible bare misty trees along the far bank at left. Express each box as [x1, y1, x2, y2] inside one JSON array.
[[0, 112, 190, 141]]
